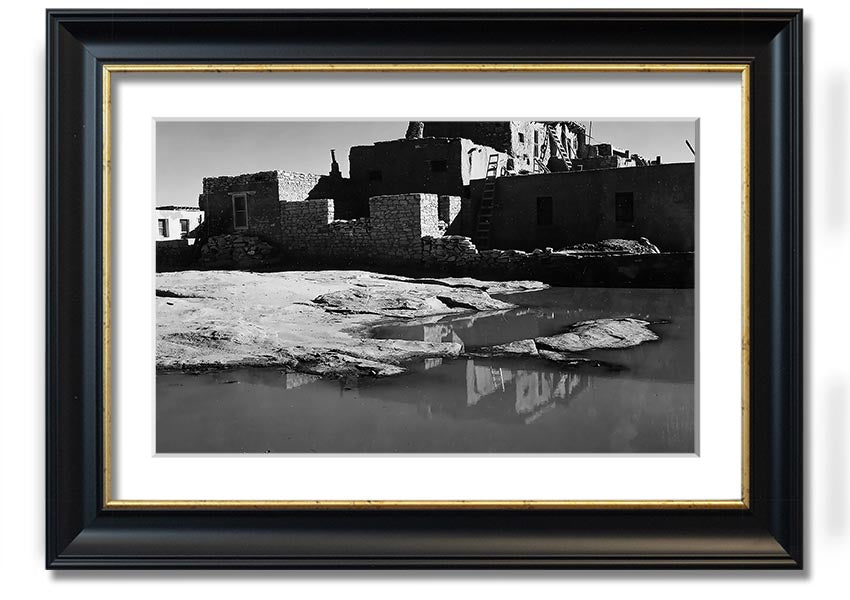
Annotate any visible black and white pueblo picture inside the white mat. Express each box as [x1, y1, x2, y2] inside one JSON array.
[[156, 116, 692, 454]]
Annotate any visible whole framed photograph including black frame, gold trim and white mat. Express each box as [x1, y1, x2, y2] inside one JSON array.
[[46, 10, 803, 569]]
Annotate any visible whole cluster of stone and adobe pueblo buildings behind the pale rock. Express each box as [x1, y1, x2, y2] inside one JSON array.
[[157, 121, 695, 287]]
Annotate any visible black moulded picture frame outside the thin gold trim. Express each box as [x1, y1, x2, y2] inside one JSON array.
[[46, 10, 803, 569]]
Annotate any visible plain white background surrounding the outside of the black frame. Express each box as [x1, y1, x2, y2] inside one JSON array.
[[0, 0, 850, 600]]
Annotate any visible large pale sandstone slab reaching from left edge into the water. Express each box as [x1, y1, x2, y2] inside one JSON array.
[[156, 270, 532, 376]]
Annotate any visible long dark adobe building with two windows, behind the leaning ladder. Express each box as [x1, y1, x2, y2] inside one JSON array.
[[468, 163, 695, 252]]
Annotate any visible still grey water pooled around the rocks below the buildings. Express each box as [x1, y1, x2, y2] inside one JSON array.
[[157, 288, 695, 453]]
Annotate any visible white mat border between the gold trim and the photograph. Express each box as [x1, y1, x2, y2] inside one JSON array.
[[111, 73, 741, 500]]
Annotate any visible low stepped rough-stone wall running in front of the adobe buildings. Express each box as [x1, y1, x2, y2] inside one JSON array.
[[274, 194, 693, 287]]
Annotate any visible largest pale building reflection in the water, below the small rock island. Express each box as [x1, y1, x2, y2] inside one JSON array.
[[466, 360, 588, 422]]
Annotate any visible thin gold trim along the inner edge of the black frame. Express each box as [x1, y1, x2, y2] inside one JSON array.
[[101, 63, 750, 510]]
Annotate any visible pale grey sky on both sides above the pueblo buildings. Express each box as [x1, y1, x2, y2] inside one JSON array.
[[155, 117, 697, 206]]
